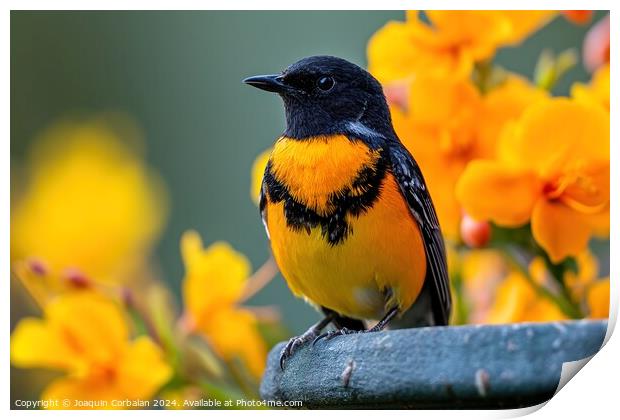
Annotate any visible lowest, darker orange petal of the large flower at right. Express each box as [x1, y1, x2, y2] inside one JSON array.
[[532, 199, 592, 263]]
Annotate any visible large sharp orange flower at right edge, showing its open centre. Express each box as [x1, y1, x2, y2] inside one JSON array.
[[456, 98, 609, 262]]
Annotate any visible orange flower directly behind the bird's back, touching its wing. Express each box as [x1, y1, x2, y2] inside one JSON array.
[[392, 75, 546, 239]]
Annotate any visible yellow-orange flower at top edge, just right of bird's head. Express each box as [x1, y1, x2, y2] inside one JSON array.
[[368, 10, 555, 83]]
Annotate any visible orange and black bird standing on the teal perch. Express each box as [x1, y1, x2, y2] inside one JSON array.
[[244, 56, 451, 366]]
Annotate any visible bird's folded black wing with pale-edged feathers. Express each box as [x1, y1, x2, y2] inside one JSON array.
[[389, 141, 452, 325]]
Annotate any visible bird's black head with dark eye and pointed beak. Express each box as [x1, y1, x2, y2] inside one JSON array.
[[244, 56, 393, 141]]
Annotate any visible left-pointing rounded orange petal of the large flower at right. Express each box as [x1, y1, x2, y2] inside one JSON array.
[[456, 160, 540, 226]]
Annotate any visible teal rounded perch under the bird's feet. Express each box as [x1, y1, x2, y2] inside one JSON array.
[[260, 320, 607, 409]]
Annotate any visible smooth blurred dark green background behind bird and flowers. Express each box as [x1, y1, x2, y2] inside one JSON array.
[[11, 11, 608, 332]]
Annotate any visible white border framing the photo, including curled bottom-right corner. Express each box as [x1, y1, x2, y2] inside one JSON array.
[[0, 0, 620, 419]]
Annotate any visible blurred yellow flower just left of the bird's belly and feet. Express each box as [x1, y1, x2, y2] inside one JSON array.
[[181, 231, 267, 377]]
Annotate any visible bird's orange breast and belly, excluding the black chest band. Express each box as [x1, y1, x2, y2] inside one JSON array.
[[266, 136, 426, 319]]
